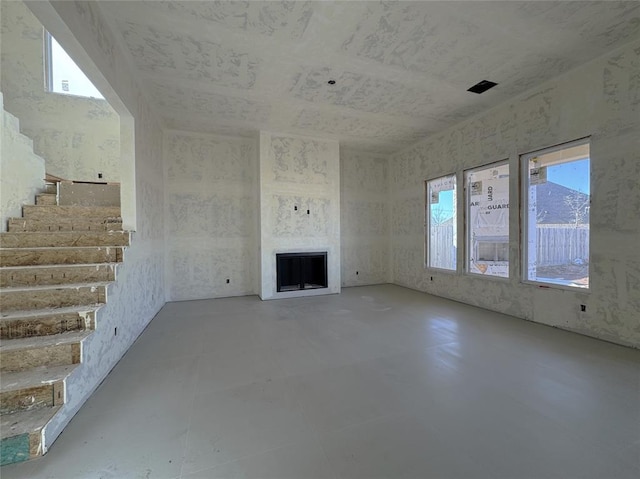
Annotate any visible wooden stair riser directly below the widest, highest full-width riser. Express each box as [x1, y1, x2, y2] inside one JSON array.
[[0, 247, 123, 267]]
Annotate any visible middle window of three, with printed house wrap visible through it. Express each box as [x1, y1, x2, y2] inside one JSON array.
[[465, 162, 509, 278]]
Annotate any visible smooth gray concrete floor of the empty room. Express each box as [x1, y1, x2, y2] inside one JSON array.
[[1, 285, 640, 479]]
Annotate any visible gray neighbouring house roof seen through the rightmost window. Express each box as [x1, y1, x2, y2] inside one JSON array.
[[536, 181, 589, 224]]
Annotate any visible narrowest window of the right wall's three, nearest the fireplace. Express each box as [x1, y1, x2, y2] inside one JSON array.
[[426, 174, 457, 271]]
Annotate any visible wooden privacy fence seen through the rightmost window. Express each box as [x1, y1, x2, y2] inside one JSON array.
[[536, 225, 589, 266]]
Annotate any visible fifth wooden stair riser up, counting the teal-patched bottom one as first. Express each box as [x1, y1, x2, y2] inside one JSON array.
[[0, 286, 107, 312]]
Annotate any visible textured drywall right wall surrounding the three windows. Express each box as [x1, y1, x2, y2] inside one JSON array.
[[391, 42, 640, 347]]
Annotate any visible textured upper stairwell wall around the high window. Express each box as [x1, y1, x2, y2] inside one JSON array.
[[0, 2, 120, 182]]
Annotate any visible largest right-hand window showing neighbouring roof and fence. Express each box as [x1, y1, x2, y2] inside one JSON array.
[[523, 140, 591, 288]]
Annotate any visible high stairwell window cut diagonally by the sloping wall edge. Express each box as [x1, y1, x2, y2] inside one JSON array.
[[44, 31, 104, 99]]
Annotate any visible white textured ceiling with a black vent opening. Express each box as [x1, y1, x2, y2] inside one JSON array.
[[100, 0, 640, 152]]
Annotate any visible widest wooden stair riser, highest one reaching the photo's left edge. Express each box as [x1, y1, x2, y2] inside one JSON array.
[[0, 231, 129, 248]]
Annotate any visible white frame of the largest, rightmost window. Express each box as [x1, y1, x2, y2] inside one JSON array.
[[520, 137, 593, 293]]
